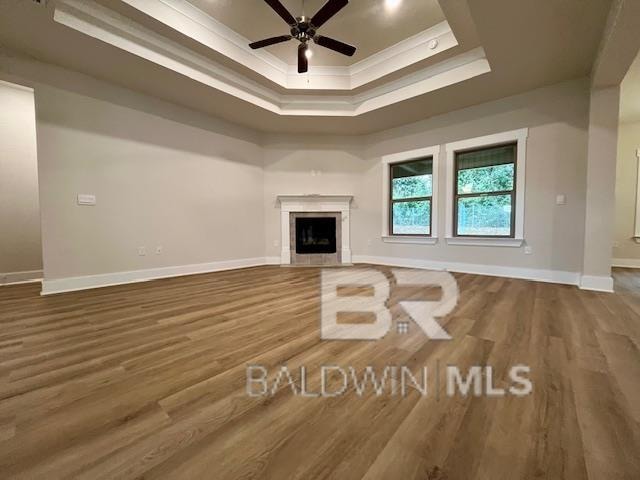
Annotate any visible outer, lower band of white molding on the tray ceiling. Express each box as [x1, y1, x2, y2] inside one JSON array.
[[54, 0, 491, 116]]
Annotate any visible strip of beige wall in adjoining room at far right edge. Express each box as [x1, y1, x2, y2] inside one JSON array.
[[613, 122, 640, 267]]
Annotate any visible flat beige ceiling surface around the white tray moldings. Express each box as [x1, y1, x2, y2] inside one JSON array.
[[0, 0, 611, 135]]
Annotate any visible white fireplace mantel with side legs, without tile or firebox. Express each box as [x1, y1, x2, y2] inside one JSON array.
[[277, 194, 353, 265]]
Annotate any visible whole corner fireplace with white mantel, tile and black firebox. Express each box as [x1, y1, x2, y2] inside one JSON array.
[[278, 195, 353, 265]]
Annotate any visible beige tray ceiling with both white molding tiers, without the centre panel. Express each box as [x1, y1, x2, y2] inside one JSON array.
[[0, 0, 611, 135]]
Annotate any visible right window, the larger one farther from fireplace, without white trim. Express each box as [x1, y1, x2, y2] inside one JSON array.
[[453, 143, 517, 238]]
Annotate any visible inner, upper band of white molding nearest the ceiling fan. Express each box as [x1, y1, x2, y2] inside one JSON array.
[[122, 0, 458, 90]]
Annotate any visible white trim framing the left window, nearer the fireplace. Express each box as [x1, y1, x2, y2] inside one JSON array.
[[381, 145, 440, 245]]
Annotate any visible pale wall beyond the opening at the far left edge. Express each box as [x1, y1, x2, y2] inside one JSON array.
[[0, 81, 42, 284]]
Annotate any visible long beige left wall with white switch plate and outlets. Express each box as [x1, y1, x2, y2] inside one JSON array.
[[31, 80, 264, 279]]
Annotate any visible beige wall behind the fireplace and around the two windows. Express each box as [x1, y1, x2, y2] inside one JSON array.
[[265, 80, 589, 282]]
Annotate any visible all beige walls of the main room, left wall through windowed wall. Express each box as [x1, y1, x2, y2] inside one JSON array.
[[0, 53, 600, 292]]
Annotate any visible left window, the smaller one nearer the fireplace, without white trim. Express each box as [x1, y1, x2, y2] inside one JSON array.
[[389, 157, 433, 236]]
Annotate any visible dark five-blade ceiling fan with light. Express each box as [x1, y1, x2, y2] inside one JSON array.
[[249, 0, 356, 73]]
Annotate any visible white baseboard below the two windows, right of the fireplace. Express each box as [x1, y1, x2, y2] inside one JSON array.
[[353, 255, 580, 285]]
